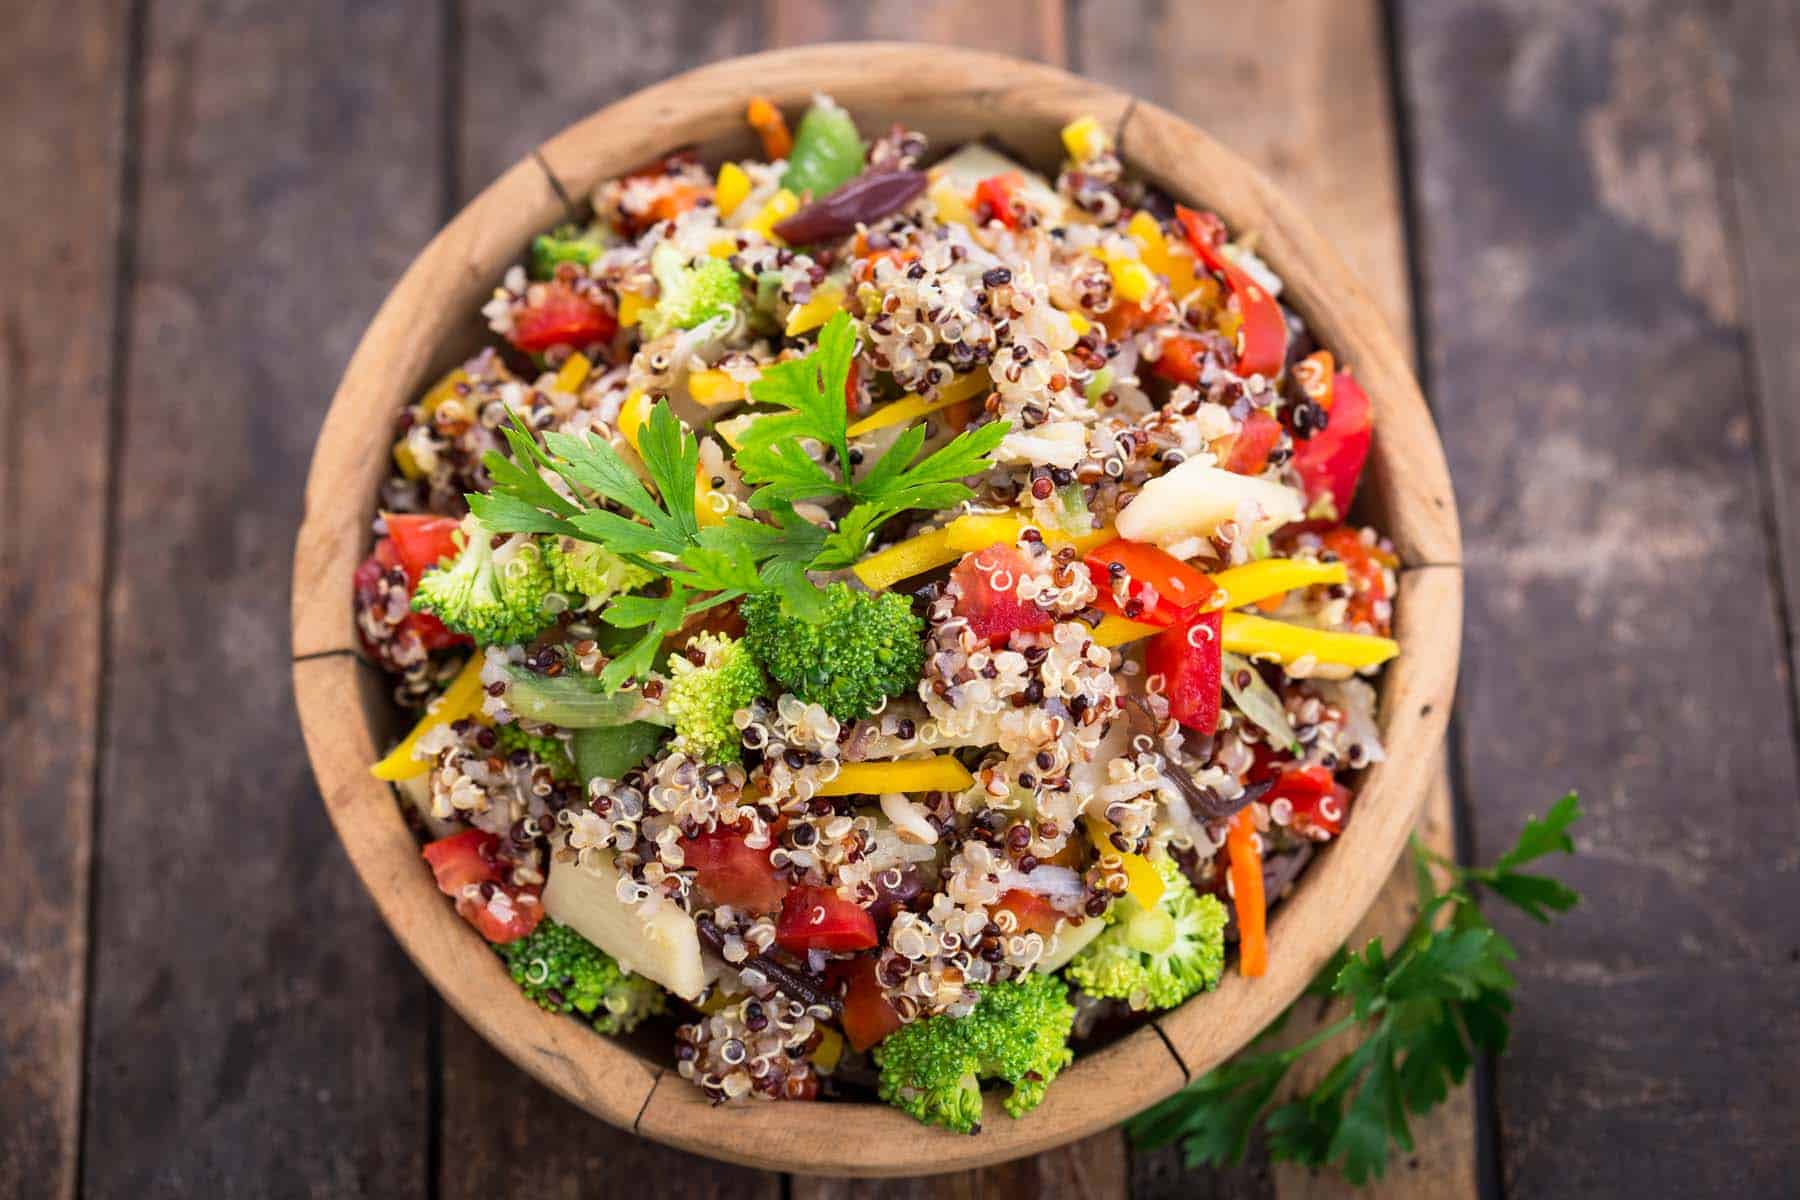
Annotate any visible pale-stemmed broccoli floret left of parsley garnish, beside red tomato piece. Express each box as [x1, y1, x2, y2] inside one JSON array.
[[412, 515, 551, 646]]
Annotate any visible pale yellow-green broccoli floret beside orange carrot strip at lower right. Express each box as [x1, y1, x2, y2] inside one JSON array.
[[1064, 858, 1226, 1009]]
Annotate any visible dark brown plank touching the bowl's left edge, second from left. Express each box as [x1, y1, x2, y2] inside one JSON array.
[[80, 2, 441, 1196]]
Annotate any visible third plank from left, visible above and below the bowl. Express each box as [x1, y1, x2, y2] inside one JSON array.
[[437, 9, 781, 1200]]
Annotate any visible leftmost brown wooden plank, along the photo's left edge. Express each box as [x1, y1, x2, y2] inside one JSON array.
[[0, 4, 128, 1196]]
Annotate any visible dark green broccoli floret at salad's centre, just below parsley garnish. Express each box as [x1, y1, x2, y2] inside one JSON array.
[[740, 583, 925, 721]]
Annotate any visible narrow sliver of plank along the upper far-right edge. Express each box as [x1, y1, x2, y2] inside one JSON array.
[[1730, 4, 1800, 726]]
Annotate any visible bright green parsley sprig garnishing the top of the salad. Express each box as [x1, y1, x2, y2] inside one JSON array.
[[468, 313, 1008, 689]]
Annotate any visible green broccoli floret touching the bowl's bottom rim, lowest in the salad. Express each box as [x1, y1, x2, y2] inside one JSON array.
[[875, 973, 1075, 1133]]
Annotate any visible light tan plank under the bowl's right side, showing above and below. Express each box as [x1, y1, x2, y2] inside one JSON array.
[[1075, 0, 1476, 1200]]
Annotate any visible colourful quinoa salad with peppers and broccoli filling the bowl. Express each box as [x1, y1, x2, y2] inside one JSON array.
[[353, 95, 1399, 1133]]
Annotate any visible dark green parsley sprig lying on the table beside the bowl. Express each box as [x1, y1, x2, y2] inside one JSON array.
[[1127, 792, 1580, 1186]]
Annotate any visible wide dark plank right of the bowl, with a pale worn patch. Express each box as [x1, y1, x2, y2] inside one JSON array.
[[1400, 0, 1800, 1196]]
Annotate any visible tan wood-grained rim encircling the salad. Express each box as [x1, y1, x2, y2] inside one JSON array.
[[297, 43, 1460, 1175]]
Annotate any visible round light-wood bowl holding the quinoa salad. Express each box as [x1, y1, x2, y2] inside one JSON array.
[[293, 43, 1462, 1175]]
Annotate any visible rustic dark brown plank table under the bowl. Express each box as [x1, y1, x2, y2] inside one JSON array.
[[0, 0, 1800, 1200]]
